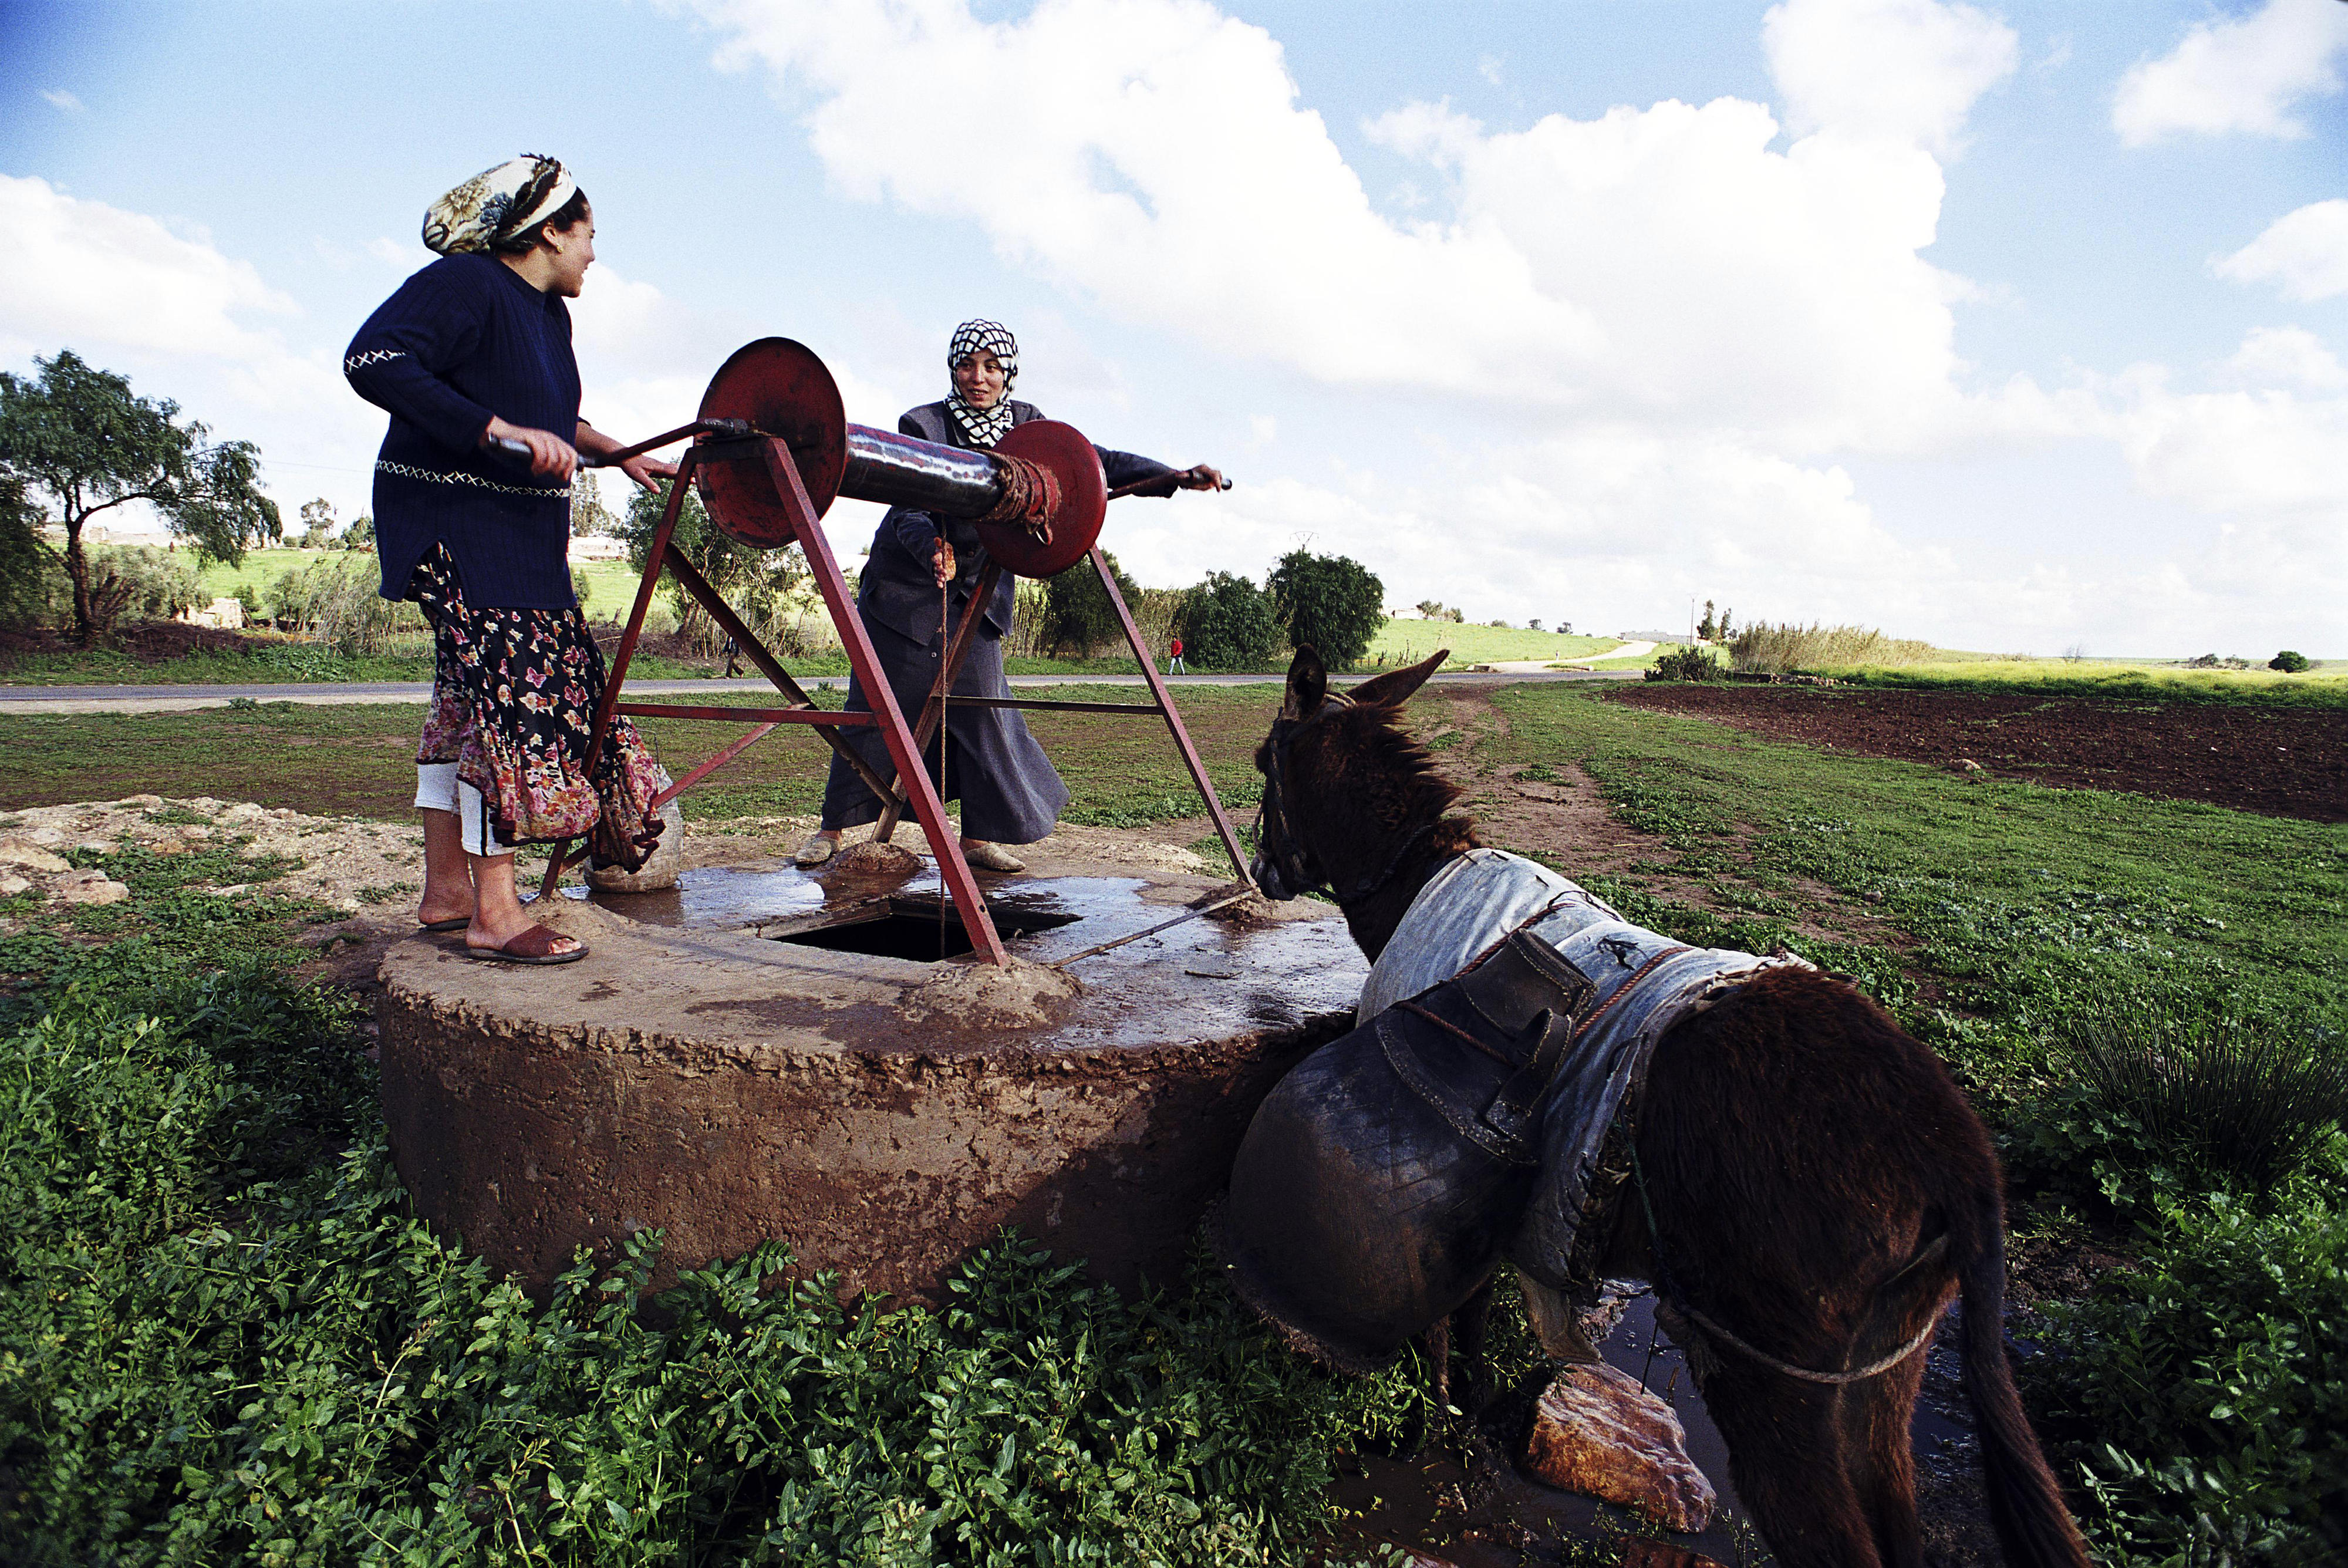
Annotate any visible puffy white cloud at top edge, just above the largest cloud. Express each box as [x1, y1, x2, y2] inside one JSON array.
[[1761, 0, 2017, 157]]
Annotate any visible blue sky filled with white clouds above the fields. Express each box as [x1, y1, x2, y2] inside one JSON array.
[[0, 0, 2348, 660]]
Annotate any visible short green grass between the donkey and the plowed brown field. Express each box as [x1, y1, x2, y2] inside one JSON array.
[[1479, 686, 2348, 1101]]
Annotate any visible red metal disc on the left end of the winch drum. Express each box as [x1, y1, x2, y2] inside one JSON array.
[[695, 338, 848, 549]]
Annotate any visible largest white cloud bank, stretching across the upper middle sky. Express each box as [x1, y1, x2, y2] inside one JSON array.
[[702, 0, 2015, 446]]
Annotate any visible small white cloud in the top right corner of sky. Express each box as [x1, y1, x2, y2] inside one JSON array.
[[2111, 0, 2348, 148]]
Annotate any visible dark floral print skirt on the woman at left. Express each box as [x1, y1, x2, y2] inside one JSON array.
[[409, 545, 669, 871]]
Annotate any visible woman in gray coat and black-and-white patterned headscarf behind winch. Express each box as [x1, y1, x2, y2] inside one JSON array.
[[798, 322, 1223, 871]]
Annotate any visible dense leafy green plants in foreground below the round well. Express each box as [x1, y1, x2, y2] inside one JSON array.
[[0, 990, 1428, 1566]]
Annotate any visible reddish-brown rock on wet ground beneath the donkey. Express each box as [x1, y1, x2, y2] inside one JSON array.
[[1524, 1361, 1719, 1533]]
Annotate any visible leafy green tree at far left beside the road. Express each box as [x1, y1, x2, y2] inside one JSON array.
[[0, 350, 284, 643]]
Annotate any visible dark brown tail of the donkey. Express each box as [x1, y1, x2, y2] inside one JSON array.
[[1958, 1204, 2087, 1568]]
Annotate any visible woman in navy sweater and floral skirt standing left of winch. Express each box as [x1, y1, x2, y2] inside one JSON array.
[[343, 153, 676, 965]]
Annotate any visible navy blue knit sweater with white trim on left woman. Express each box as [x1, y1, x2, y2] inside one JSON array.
[[343, 256, 580, 611]]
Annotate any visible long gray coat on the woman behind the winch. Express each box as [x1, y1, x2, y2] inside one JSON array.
[[824, 399, 1174, 845]]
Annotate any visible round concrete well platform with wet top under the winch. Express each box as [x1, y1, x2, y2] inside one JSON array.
[[378, 861, 1364, 1300]]
